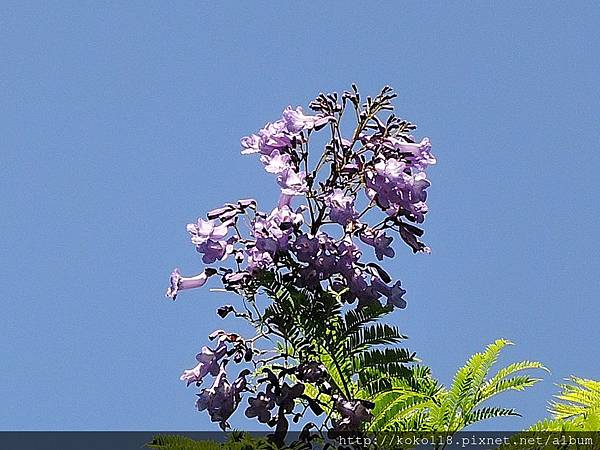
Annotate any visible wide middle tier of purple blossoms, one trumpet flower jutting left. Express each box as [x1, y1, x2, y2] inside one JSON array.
[[167, 199, 412, 308]]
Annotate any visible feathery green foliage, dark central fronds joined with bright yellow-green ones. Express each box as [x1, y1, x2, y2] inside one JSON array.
[[266, 279, 552, 433]]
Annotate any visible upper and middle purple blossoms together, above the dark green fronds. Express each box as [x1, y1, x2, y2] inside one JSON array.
[[167, 90, 436, 308]]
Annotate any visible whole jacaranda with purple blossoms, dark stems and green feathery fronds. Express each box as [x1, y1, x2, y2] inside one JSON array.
[[167, 86, 541, 444]]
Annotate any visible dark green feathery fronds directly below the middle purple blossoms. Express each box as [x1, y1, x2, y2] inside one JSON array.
[[264, 278, 415, 399]]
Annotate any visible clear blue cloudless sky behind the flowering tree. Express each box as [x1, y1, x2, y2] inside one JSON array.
[[0, 0, 600, 430]]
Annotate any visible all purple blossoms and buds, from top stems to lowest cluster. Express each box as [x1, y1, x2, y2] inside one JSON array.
[[166, 89, 436, 431]]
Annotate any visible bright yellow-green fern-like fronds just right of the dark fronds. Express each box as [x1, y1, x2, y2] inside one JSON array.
[[369, 339, 544, 433]]
